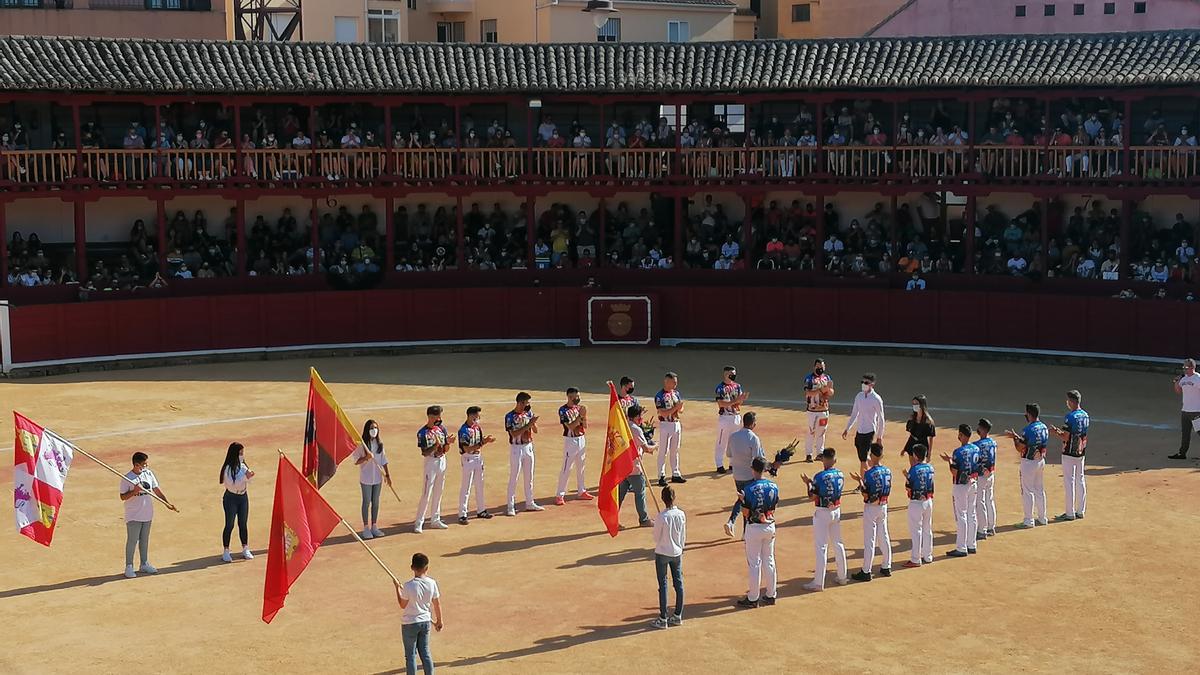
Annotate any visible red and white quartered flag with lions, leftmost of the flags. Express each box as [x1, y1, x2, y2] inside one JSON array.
[[12, 411, 74, 546]]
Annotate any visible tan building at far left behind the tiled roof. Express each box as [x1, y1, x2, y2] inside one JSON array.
[[0, 0, 230, 40]]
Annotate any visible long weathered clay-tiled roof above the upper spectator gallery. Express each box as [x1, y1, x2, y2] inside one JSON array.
[[0, 30, 1200, 95]]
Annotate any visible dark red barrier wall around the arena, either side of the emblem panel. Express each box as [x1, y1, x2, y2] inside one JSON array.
[[4, 286, 1200, 364]]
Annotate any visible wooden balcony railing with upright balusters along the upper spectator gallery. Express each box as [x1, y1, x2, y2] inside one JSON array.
[[0, 145, 1200, 187]]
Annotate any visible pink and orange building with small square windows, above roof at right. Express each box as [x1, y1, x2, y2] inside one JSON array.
[[758, 0, 1200, 38]]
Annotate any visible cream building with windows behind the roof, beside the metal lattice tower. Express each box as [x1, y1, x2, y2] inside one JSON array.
[[238, 0, 756, 43]]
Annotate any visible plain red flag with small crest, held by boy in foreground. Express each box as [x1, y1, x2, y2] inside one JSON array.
[[263, 455, 342, 623]]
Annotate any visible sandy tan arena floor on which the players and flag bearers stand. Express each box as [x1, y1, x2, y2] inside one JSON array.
[[0, 350, 1200, 674]]
